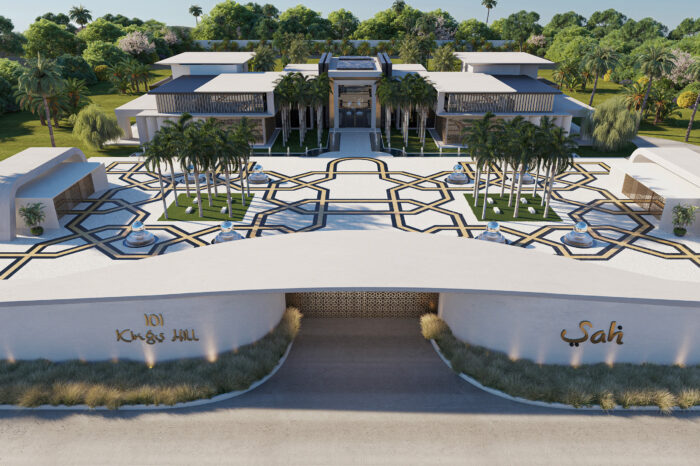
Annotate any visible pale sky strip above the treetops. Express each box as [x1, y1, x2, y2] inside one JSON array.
[[5, 0, 700, 31]]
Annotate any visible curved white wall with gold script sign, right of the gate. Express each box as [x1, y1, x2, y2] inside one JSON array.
[[439, 293, 700, 365]]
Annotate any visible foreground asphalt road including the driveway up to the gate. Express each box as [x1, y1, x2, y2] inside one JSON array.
[[0, 319, 700, 466]]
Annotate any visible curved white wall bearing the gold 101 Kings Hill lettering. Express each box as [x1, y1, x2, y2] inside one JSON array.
[[0, 293, 285, 363]]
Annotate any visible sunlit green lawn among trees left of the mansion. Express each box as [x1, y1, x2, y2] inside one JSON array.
[[0, 69, 170, 160]]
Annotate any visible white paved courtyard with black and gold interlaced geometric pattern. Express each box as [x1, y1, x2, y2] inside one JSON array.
[[0, 156, 700, 282]]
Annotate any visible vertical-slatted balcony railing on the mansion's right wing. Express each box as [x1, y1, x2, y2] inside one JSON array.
[[444, 93, 554, 113]]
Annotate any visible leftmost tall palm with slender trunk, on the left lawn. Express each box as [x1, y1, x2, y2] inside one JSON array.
[[17, 54, 65, 147]]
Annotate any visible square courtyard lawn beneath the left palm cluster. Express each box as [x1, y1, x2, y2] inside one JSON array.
[[158, 192, 254, 222]]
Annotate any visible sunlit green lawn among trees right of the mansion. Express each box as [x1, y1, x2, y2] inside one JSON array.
[[539, 70, 700, 145]]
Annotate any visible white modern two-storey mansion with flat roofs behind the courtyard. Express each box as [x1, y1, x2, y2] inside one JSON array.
[[115, 52, 592, 146]]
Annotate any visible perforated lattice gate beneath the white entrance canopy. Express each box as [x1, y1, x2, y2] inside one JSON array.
[[286, 291, 440, 318]]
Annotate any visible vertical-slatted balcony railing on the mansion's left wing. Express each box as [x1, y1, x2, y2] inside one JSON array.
[[156, 93, 267, 113]]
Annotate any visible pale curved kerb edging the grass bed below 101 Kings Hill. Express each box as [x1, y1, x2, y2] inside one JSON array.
[[0, 341, 294, 411]]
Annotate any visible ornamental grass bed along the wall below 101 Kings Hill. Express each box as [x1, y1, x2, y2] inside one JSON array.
[[0, 308, 302, 409]]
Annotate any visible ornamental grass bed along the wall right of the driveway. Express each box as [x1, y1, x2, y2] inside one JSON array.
[[420, 314, 700, 413]]
